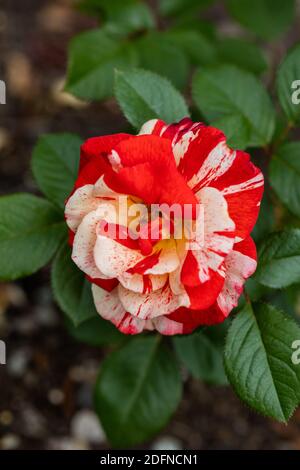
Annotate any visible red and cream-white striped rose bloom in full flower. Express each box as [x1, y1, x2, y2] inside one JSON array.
[[65, 118, 263, 335]]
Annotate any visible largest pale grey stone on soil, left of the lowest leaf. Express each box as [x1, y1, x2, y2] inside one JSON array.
[[71, 410, 106, 444]]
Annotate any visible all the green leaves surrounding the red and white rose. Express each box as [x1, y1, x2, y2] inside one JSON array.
[[0, 0, 300, 447]]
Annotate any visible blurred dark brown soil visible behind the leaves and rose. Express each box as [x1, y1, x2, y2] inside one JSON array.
[[0, 0, 300, 449]]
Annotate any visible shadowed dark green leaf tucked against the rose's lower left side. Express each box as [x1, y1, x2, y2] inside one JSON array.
[[51, 243, 98, 326]]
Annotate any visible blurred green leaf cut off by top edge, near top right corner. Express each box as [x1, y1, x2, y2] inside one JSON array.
[[227, 0, 295, 40]]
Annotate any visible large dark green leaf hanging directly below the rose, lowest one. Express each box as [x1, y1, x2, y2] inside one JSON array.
[[95, 335, 181, 448]]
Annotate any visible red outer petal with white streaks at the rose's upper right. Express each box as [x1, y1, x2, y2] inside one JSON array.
[[140, 119, 263, 239]]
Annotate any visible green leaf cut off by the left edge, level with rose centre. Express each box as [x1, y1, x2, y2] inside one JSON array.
[[0, 193, 66, 280]]
